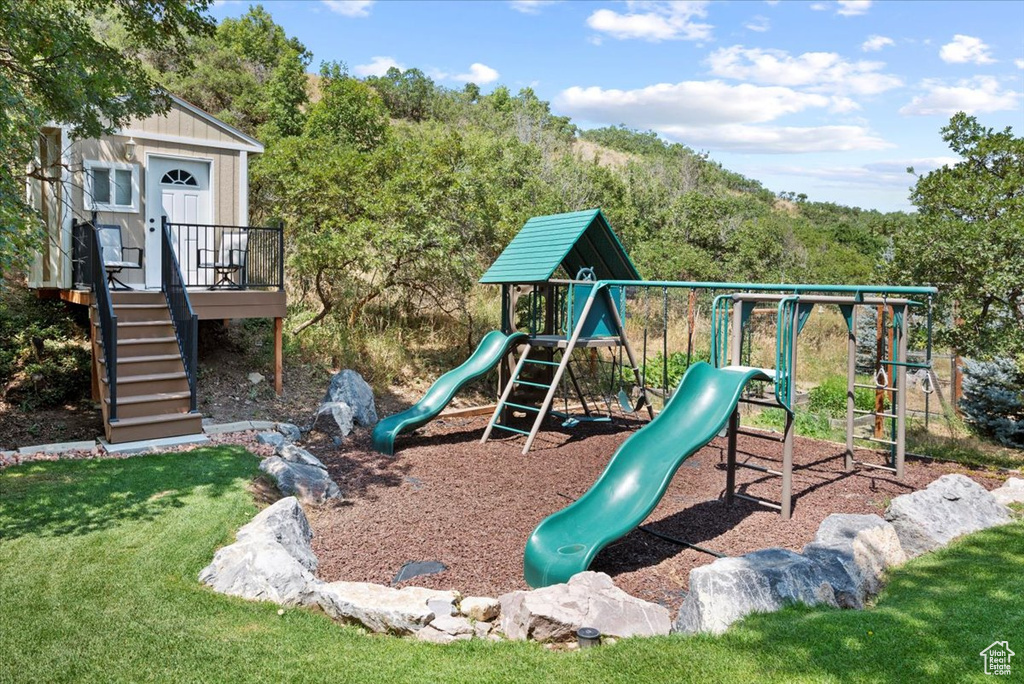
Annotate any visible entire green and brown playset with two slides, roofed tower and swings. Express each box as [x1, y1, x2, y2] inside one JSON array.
[[373, 209, 936, 587]]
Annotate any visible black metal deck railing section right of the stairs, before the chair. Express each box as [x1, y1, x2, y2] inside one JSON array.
[[167, 222, 285, 290]]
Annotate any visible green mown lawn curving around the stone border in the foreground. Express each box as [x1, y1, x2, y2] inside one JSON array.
[[0, 447, 1024, 684]]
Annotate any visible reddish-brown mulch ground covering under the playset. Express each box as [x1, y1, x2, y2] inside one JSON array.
[[307, 418, 999, 610]]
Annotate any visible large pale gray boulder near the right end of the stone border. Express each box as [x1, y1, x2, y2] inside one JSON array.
[[886, 474, 1011, 558]]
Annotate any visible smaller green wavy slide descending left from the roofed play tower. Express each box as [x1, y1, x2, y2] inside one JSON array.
[[373, 330, 529, 456]]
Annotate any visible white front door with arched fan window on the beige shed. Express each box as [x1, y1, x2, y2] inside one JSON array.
[[145, 156, 214, 289]]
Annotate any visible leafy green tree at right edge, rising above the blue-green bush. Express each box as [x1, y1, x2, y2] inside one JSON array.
[[892, 113, 1024, 357]]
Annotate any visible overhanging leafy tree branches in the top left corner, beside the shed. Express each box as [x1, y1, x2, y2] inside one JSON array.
[[0, 0, 213, 274]]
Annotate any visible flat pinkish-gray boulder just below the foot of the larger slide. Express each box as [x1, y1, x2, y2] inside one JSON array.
[[499, 571, 672, 641]]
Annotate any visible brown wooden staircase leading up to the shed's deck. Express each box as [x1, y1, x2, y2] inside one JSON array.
[[91, 292, 203, 443]]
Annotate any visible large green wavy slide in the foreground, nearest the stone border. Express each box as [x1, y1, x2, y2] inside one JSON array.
[[523, 361, 769, 588]]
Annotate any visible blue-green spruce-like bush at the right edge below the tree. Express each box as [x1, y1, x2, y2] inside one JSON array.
[[959, 358, 1024, 447]]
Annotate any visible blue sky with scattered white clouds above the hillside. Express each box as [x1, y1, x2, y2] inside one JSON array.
[[212, 0, 1024, 211]]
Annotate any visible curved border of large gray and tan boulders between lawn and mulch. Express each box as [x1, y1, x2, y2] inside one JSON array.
[[199, 475, 1024, 649]]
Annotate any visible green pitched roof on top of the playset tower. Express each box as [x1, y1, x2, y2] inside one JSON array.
[[480, 209, 641, 285]]
